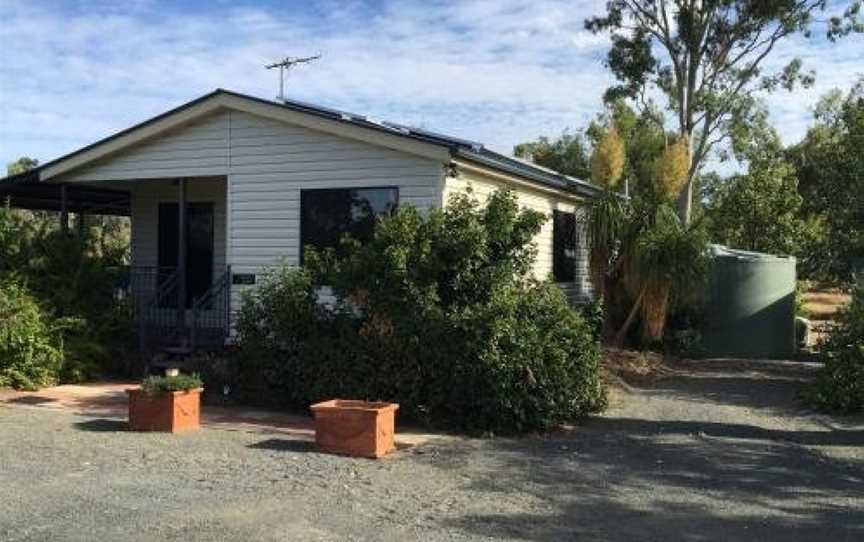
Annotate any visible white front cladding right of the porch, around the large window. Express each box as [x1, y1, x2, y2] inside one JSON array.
[[228, 112, 444, 308]]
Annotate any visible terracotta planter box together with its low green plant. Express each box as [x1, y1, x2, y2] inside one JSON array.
[[126, 374, 203, 433]]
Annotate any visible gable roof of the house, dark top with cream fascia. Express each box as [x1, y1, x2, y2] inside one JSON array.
[[0, 89, 602, 200]]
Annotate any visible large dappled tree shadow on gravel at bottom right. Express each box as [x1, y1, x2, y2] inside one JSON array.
[[447, 428, 864, 541]]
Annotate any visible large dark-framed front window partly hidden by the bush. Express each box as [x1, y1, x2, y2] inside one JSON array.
[[300, 187, 399, 263]]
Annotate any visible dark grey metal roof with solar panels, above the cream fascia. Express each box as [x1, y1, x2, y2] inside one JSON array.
[[0, 88, 603, 197]]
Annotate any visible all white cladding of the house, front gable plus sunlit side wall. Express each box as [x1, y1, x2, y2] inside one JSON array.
[[50, 96, 591, 330]]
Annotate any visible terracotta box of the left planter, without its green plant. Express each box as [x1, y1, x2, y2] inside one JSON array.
[[126, 388, 203, 433]]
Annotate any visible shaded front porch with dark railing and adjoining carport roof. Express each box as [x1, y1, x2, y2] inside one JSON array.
[[0, 173, 231, 356]]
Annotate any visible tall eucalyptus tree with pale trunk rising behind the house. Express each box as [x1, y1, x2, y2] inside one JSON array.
[[585, 0, 864, 223]]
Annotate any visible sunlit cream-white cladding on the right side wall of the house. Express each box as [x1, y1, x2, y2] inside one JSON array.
[[442, 166, 592, 303]]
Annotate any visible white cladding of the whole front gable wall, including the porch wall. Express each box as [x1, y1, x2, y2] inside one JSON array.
[[55, 104, 444, 318]]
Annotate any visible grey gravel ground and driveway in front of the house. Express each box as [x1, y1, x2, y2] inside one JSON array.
[[0, 362, 864, 541]]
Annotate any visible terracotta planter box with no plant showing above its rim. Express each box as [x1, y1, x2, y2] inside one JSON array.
[[311, 399, 399, 458]]
